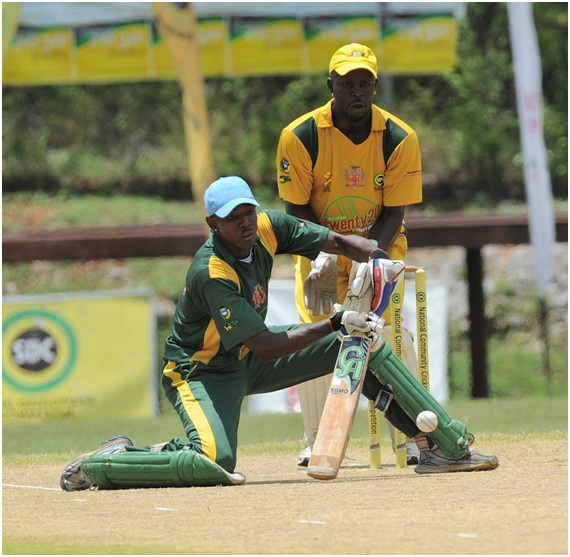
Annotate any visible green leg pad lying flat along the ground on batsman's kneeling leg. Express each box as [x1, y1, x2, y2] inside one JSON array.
[[82, 449, 245, 489]]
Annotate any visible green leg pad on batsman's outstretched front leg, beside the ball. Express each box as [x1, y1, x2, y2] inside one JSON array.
[[368, 342, 469, 458]]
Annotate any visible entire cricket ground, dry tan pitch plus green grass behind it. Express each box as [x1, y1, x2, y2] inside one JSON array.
[[2, 398, 568, 555]]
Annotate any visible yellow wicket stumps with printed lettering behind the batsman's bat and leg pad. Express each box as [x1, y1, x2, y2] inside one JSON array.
[[368, 265, 430, 469]]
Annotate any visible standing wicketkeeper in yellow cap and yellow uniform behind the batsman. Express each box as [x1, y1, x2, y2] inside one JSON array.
[[276, 44, 422, 466]]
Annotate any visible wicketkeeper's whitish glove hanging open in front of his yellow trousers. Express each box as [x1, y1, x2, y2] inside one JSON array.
[[303, 251, 338, 315]]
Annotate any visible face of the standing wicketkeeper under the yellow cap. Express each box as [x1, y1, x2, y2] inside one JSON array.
[[327, 69, 378, 123]]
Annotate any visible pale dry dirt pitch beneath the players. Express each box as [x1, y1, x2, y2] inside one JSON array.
[[2, 439, 568, 555]]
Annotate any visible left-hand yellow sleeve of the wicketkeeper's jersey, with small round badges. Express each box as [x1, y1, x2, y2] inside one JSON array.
[[276, 128, 313, 205]]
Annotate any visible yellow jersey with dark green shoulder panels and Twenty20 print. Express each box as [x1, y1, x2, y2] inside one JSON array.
[[276, 101, 422, 236]]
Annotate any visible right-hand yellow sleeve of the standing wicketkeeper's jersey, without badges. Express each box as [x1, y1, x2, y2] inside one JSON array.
[[383, 132, 422, 207]]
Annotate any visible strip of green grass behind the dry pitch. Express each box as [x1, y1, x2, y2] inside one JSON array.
[[2, 398, 568, 466]]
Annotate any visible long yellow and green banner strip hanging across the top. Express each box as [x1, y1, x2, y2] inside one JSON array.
[[2, 2, 457, 85]]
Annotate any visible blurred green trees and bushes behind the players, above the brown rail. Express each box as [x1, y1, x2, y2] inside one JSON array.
[[2, 2, 568, 206]]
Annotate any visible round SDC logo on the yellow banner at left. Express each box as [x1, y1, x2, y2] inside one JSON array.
[[2, 309, 77, 392]]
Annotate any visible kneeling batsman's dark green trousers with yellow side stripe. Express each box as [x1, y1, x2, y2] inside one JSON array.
[[162, 325, 419, 472]]
